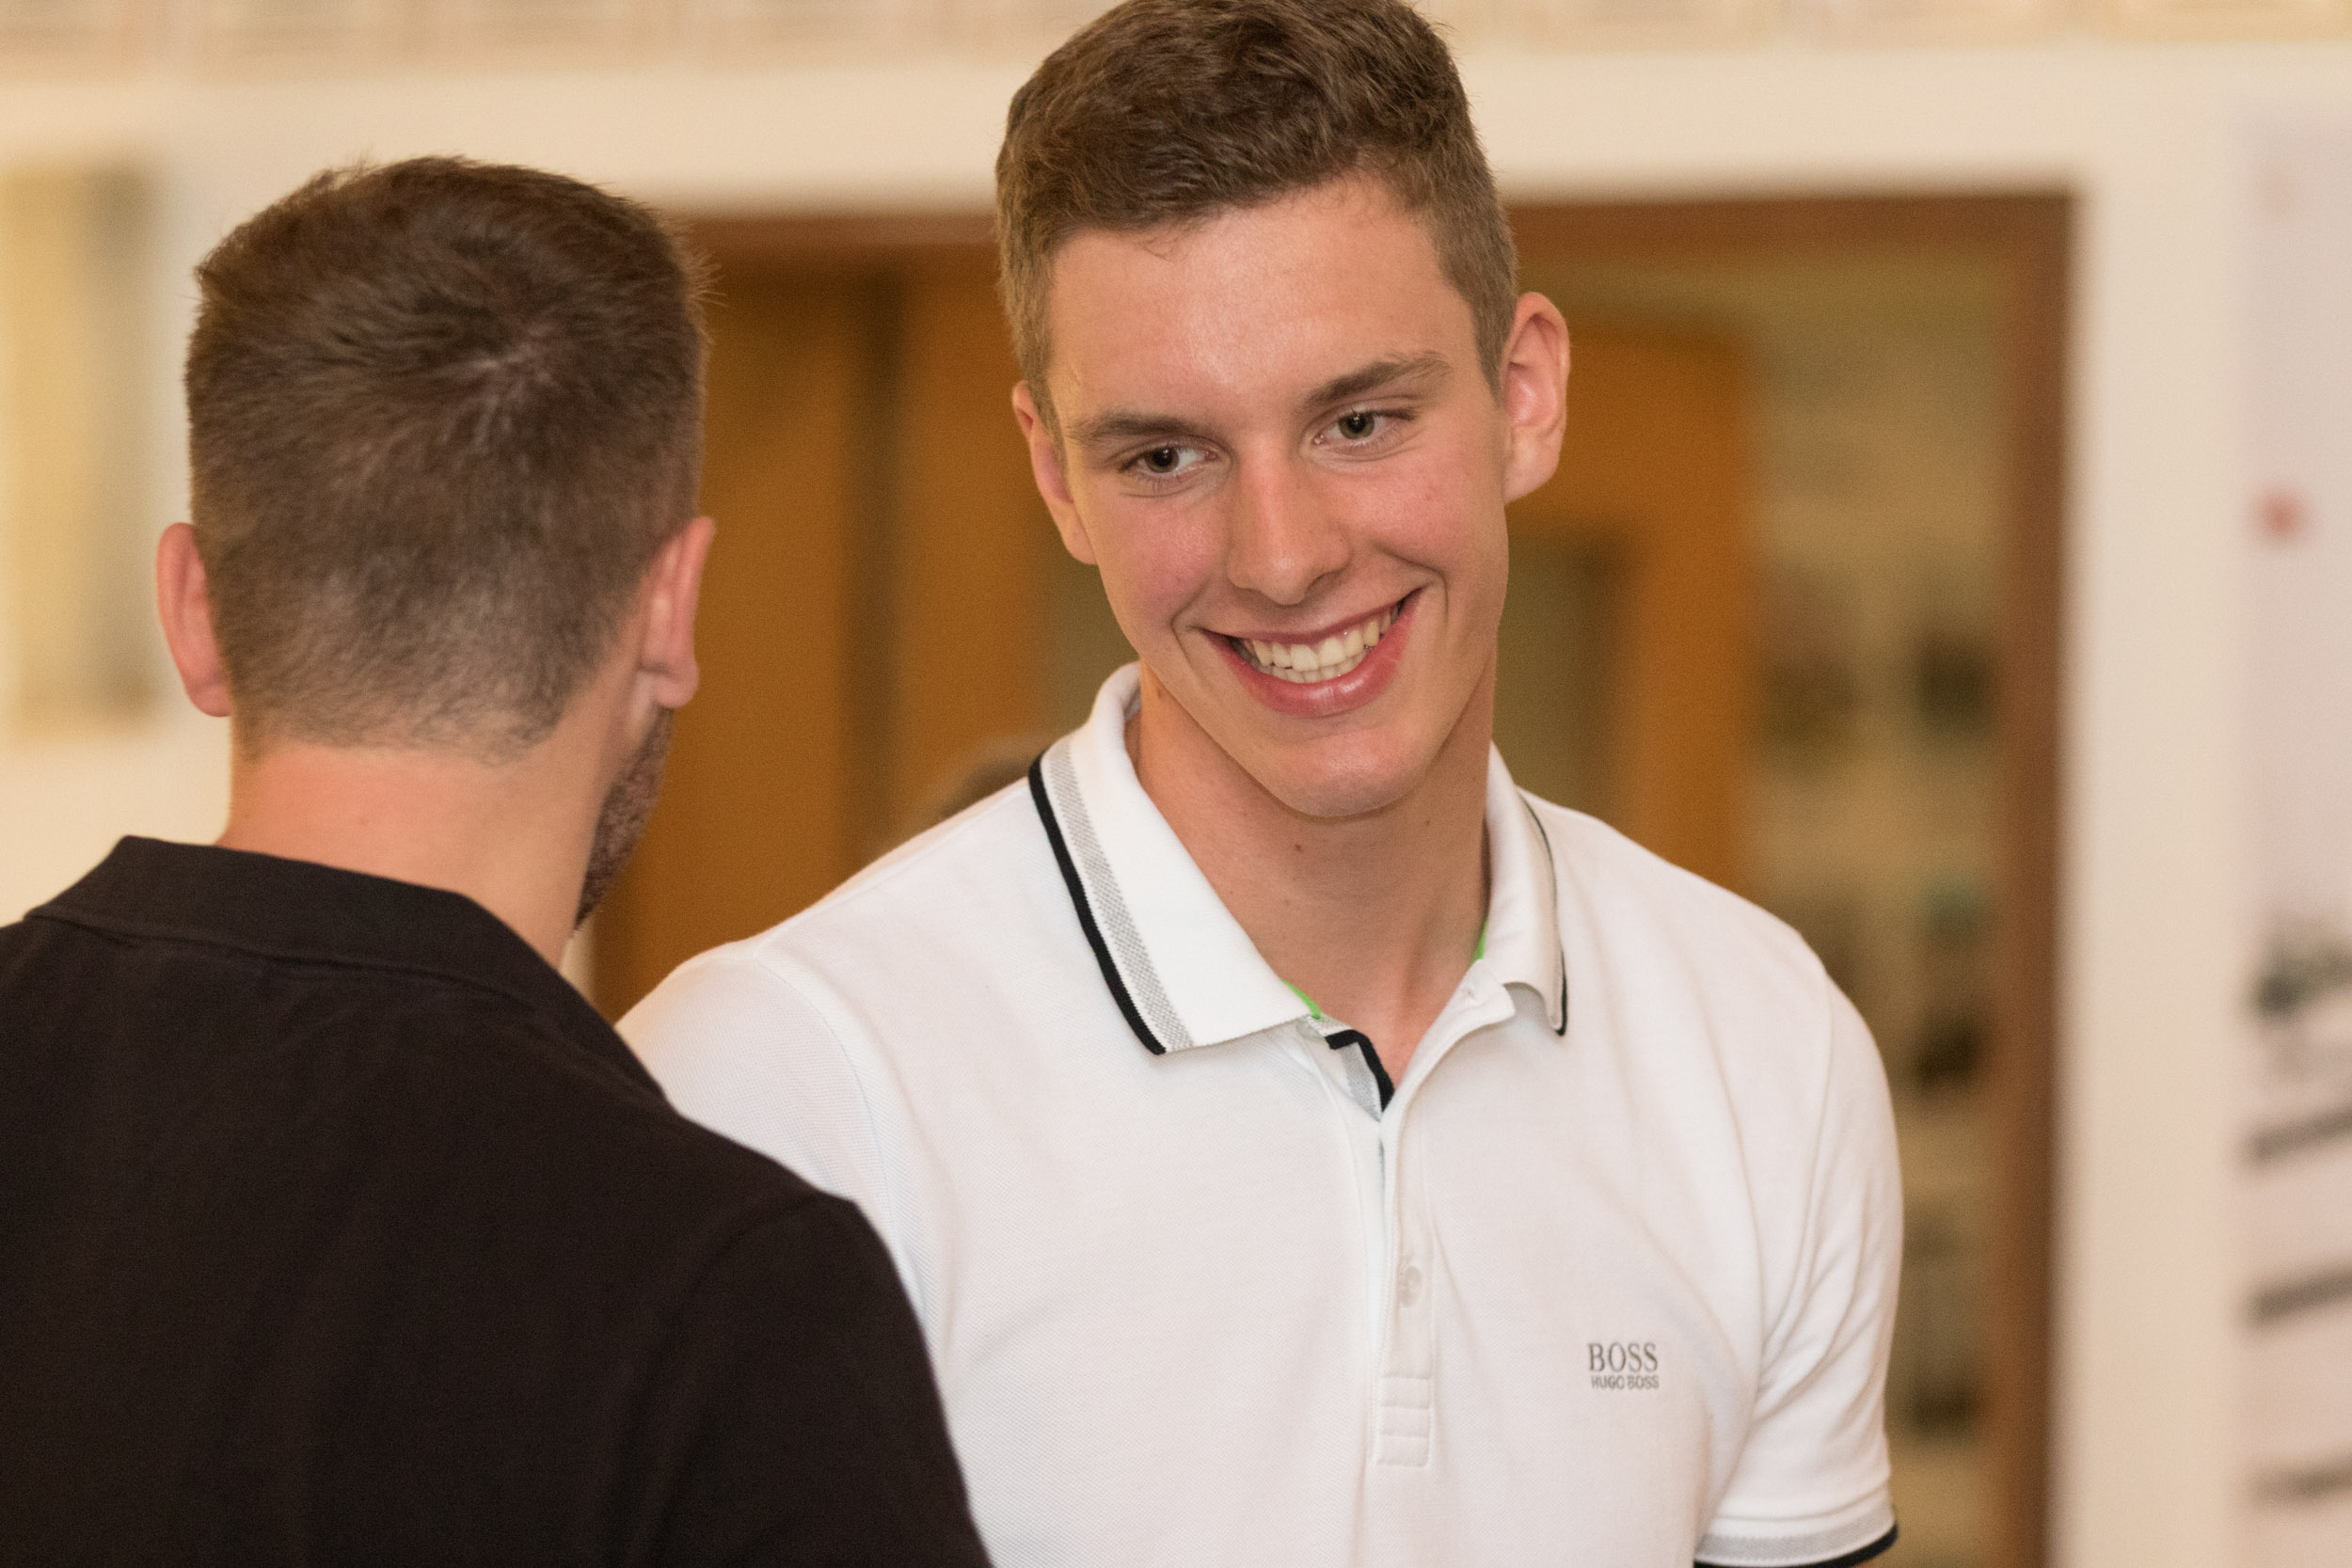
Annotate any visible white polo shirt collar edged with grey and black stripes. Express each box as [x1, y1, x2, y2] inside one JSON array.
[[1030, 665, 1566, 1053]]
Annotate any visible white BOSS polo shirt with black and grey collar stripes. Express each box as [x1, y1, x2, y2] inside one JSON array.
[[621, 665, 1900, 1568]]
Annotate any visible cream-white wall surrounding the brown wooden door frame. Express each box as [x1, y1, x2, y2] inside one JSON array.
[[0, 38, 2352, 1568]]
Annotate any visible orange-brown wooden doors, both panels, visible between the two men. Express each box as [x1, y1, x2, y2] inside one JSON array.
[[593, 235, 1058, 1018]]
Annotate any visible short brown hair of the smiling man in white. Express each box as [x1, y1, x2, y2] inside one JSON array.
[[997, 0, 1518, 419]]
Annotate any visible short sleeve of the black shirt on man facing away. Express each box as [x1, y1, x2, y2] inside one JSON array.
[[626, 1195, 988, 1568]]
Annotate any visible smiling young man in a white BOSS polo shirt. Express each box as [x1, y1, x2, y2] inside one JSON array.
[[626, 0, 1900, 1568]]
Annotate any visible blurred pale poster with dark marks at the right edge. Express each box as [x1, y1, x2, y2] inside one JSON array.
[[2244, 119, 2352, 1568]]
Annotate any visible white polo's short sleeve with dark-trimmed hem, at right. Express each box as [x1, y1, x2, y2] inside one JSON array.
[[1698, 983, 1903, 1568]]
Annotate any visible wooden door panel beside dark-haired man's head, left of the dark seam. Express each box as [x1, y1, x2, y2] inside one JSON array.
[[596, 273, 898, 1018]]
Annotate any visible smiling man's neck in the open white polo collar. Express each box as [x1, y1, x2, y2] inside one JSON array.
[[1127, 673, 1494, 1082]]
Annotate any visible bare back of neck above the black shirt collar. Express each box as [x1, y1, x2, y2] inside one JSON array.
[[219, 731, 597, 964]]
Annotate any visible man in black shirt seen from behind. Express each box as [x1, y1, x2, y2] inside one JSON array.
[[0, 160, 983, 1568]]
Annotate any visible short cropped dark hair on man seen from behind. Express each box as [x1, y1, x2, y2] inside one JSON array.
[[186, 157, 706, 757]]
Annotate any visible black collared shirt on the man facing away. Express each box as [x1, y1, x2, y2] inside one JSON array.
[[0, 839, 986, 1568]]
